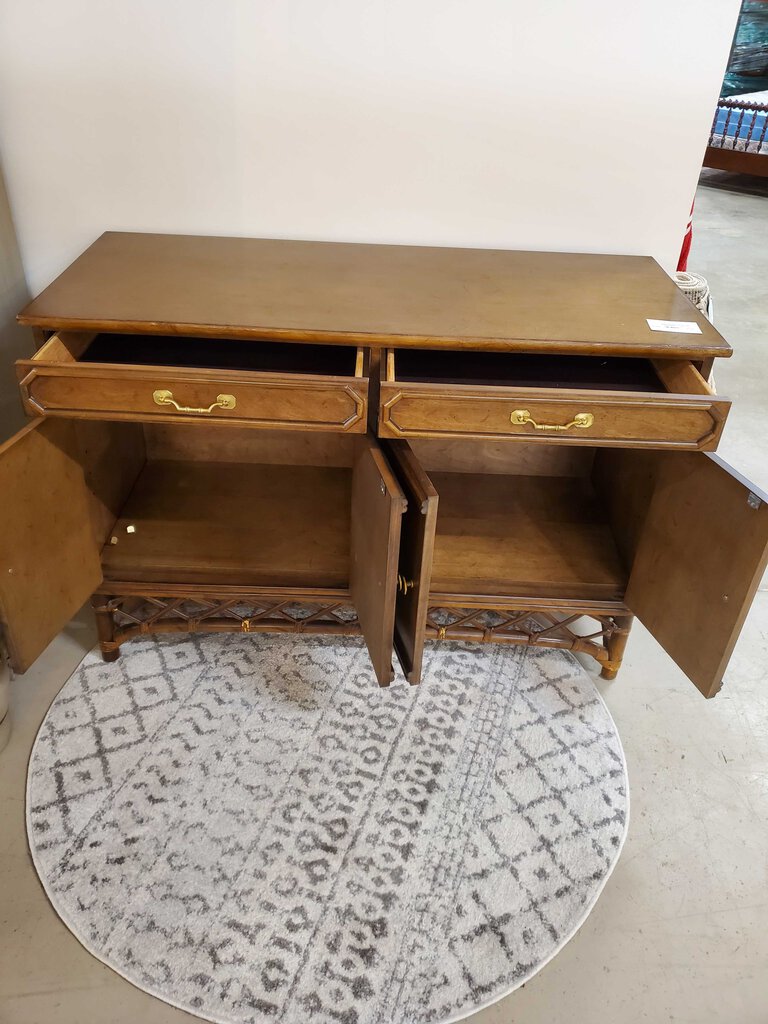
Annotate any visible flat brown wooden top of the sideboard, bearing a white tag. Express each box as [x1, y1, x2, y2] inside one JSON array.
[[18, 231, 731, 358]]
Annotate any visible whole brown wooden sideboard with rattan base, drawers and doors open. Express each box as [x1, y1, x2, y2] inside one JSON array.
[[0, 232, 768, 696]]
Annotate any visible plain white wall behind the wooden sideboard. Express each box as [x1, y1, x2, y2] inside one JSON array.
[[0, 0, 739, 292]]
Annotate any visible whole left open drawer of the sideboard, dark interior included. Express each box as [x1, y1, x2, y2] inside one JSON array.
[[16, 332, 368, 433]]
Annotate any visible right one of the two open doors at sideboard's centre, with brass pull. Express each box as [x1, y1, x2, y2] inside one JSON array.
[[385, 441, 437, 683]]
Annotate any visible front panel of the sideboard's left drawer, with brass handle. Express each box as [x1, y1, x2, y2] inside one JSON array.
[[19, 361, 368, 433]]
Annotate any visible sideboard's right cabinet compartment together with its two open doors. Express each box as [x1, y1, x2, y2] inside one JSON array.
[[386, 440, 768, 696]]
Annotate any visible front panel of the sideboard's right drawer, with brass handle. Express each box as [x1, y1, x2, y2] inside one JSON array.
[[379, 381, 730, 451]]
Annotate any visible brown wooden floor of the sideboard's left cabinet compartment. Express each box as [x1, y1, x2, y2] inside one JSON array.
[[101, 460, 351, 587]]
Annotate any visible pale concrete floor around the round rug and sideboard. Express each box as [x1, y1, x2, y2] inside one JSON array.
[[0, 189, 768, 1024]]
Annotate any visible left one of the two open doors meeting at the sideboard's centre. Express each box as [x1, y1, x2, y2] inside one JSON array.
[[349, 437, 407, 686]]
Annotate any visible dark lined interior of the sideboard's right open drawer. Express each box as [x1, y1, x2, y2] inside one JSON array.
[[387, 348, 692, 393]]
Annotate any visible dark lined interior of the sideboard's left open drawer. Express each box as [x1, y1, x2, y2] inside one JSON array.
[[78, 334, 361, 377]]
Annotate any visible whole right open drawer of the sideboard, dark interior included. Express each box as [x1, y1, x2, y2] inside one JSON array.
[[379, 349, 730, 451]]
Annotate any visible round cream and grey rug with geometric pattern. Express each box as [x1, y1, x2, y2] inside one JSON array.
[[28, 635, 629, 1024]]
